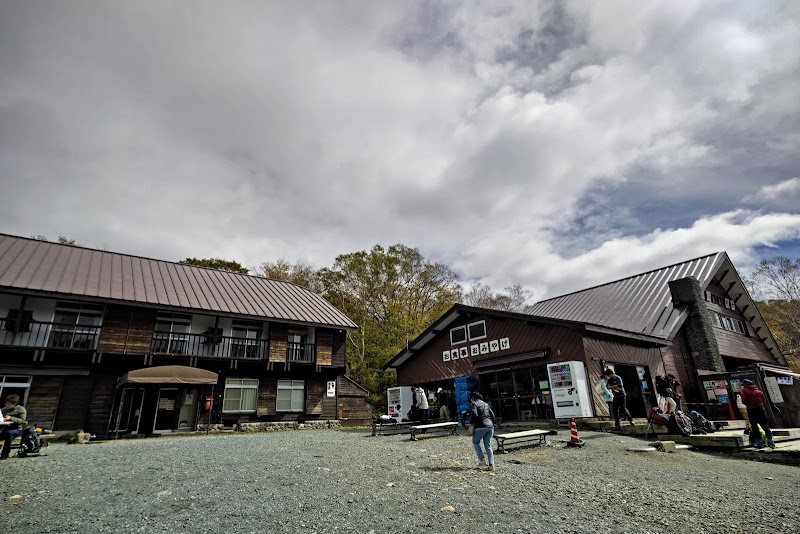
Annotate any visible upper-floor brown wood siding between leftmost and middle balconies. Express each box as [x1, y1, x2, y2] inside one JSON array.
[[97, 306, 156, 354]]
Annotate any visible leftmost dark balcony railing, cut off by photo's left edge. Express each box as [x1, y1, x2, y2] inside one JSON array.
[[0, 319, 100, 350]]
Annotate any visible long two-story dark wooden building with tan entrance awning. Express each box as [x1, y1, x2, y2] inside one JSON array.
[[0, 234, 371, 435]]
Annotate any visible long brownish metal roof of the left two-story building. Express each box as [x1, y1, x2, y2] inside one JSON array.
[[0, 234, 356, 328]]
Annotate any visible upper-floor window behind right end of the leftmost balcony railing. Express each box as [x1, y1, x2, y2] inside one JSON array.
[[47, 302, 103, 350]]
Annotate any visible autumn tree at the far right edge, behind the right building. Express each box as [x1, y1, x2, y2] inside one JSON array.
[[749, 256, 800, 371]]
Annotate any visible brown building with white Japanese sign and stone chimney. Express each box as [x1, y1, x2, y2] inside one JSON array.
[[386, 252, 788, 426]]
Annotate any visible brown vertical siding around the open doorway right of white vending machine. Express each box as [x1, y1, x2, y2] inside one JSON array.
[[583, 334, 664, 415]]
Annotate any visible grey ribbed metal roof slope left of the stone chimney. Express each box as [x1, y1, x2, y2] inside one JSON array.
[[528, 252, 727, 339]]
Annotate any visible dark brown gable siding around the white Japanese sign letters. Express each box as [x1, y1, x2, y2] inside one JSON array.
[[397, 315, 584, 386]]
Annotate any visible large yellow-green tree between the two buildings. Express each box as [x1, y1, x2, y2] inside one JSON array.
[[319, 244, 461, 409]]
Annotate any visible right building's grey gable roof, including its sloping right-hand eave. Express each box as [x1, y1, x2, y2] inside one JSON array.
[[528, 252, 785, 362]]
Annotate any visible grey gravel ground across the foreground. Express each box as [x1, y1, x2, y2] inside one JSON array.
[[0, 430, 800, 534]]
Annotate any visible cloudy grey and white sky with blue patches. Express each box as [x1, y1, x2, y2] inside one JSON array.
[[0, 0, 800, 300]]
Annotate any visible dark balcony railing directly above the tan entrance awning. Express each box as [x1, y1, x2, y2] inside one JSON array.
[[150, 332, 269, 360]]
